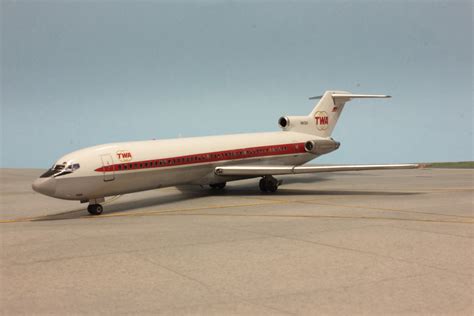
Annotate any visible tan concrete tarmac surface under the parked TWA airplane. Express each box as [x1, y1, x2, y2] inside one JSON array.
[[0, 169, 474, 315]]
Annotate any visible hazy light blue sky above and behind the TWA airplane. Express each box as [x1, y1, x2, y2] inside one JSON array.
[[1, 0, 473, 168]]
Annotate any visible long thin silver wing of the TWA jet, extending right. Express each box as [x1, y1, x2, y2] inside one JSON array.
[[214, 164, 420, 177]]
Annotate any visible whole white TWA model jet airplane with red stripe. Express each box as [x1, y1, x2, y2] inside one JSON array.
[[33, 91, 418, 215]]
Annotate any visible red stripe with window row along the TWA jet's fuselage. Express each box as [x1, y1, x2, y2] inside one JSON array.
[[95, 143, 305, 172]]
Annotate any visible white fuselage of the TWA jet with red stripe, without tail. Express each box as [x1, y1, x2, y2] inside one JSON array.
[[34, 131, 318, 201]]
